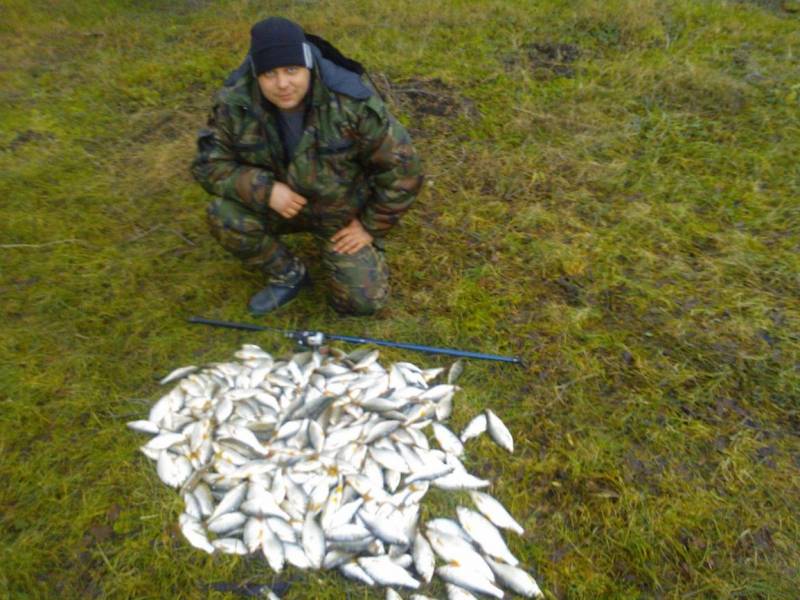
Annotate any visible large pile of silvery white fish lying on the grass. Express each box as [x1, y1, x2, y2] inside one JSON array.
[[128, 344, 541, 600]]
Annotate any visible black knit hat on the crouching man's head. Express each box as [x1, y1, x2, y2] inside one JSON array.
[[250, 17, 313, 75]]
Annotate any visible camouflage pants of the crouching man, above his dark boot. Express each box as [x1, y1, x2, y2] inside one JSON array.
[[208, 198, 389, 315]]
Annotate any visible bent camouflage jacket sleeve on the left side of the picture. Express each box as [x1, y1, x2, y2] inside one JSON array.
[[192, 103, 274, 212]]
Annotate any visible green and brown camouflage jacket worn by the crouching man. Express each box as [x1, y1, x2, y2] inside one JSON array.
[[192, 48, 422, 238]]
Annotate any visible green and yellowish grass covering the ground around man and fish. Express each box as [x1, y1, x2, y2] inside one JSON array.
[[0, 0, 800, 599]]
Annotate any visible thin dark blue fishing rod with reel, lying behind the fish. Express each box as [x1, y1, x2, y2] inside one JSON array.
[[187, 317, 522, 365]]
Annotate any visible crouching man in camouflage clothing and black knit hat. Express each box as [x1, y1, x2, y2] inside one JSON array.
[[192, 17, 422, 315]]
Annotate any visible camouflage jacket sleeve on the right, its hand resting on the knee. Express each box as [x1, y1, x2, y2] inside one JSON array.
[[358, 96, 423, 237]]
